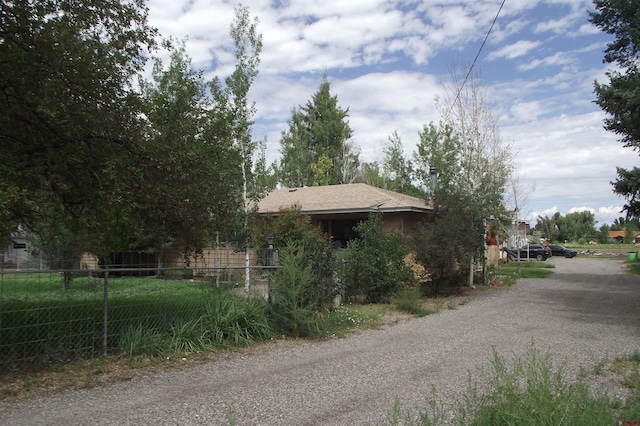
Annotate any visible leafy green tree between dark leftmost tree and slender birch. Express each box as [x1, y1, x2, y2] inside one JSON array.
[[139, 43, 241, 254]]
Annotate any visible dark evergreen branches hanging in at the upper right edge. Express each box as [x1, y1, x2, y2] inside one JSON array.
[[589, 0, 640, 217]]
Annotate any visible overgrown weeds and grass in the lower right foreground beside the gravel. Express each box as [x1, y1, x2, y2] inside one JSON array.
[[386, 344, 640, 426]]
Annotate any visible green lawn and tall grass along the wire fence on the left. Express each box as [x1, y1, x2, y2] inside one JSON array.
[[0, 274, 270, 374]]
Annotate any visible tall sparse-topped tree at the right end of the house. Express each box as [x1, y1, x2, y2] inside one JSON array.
[[414, 67, 513, 292]]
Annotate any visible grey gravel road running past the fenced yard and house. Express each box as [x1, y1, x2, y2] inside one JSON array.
[[0, 257, 640, 425]]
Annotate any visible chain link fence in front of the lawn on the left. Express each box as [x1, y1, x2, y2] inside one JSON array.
[[0, 248, 272, 377]]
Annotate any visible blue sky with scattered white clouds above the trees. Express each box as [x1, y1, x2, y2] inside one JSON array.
[[147, 0, 638, 228]]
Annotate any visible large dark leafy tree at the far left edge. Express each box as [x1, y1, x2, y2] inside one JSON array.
[[0, 0, 155, 251]]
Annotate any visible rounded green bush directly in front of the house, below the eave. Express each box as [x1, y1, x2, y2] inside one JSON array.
[[342, 214, 414, 303]]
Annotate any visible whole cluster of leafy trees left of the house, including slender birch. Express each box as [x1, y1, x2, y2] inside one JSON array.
[[0, 0, 269, 256]]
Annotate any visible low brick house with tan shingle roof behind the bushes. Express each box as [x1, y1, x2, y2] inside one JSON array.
[[258, 183, 433, 247]]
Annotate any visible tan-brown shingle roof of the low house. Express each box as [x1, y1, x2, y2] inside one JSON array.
[[258, 183, 432, 214]]
